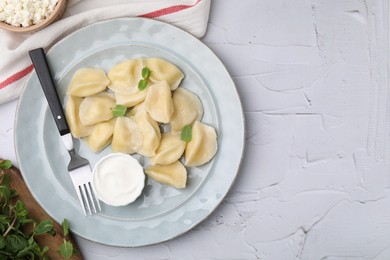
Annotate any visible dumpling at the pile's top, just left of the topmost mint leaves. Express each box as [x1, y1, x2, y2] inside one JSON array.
[[107, 59, 142, 95]]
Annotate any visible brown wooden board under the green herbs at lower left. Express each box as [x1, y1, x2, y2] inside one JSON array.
[[0, 159, 83, 260]]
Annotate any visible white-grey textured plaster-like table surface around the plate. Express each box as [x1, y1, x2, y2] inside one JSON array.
[[0, 0, 390, 260]]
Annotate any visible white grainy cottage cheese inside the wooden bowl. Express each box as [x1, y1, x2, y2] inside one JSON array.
[[0, 0, 58, 27]]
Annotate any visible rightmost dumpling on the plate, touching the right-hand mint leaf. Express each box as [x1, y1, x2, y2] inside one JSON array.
[[184, 121, 218, 166]]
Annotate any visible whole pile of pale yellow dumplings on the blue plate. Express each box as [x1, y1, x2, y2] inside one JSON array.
[[66, 58, 218, 189]]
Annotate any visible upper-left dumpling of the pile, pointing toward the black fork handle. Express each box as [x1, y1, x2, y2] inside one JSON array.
[[66, 68, 110, 97]]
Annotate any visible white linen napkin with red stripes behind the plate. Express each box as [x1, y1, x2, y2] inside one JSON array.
[[0, 0, 211, 104]]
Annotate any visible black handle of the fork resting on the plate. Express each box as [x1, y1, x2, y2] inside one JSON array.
[[29, 48, 70, 136]]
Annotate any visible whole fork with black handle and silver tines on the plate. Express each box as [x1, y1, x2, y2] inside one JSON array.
[[29, 48, 101, 216]]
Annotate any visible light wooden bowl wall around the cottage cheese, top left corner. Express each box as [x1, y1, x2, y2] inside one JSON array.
[[0, 0, 68, 33]]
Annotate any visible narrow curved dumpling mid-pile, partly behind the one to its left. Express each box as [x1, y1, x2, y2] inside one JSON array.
[[133, 111, 161, 157]]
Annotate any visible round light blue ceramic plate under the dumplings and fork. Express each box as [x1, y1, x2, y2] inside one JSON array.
[[15, 18, 244, 247]]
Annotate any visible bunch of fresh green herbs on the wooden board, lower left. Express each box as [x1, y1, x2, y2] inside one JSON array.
[[0, 160, 78, 259]]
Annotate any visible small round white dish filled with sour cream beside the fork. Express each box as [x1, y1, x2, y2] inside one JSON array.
[[92, 153, 145, 206]]
